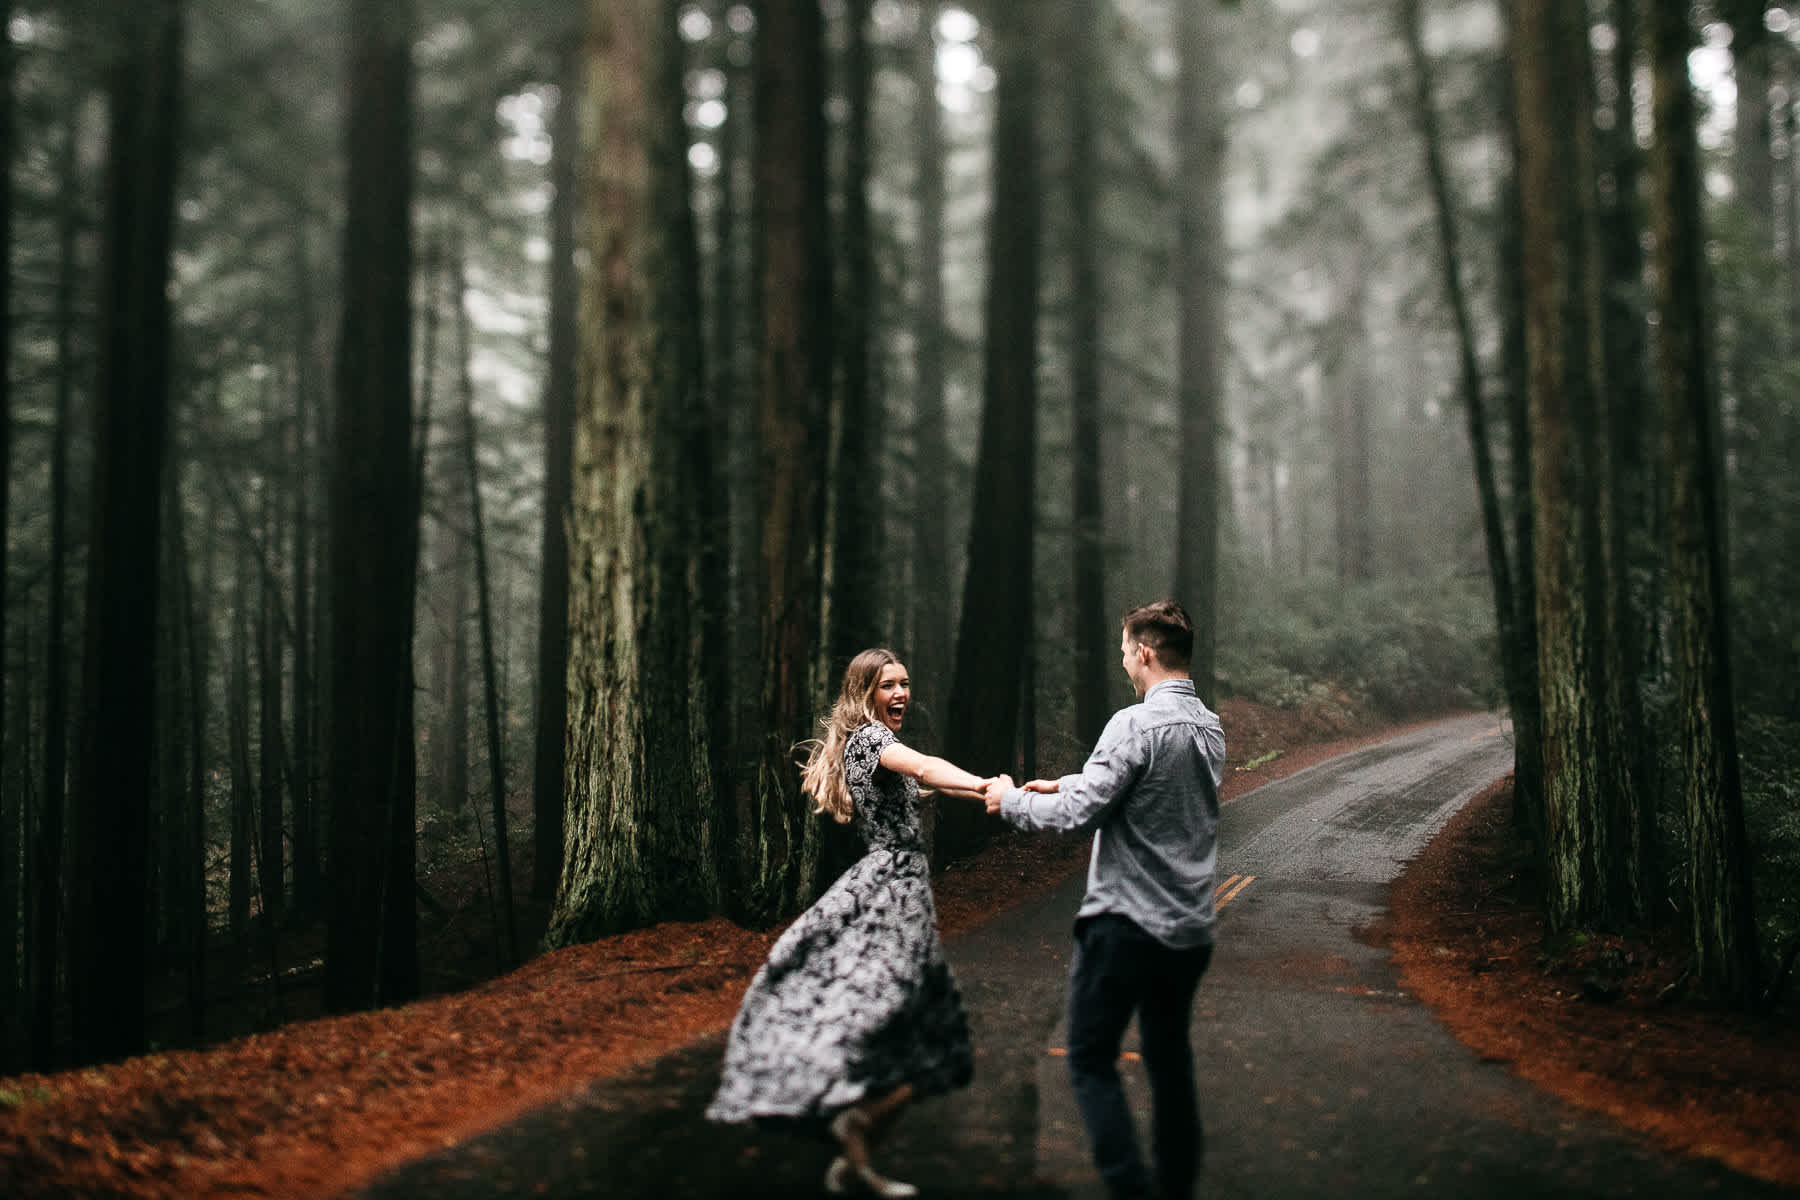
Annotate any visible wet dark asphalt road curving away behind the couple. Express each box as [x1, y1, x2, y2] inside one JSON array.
[[364, 716, 1800, 1200]]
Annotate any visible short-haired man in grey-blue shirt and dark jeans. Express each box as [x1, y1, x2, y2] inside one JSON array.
[[986, 601, 1226, 1200]]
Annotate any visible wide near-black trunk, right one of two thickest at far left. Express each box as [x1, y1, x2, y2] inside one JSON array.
[[324, 0, 419, 1011]]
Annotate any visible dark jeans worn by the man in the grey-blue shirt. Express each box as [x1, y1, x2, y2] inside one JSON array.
[[1069, 914, 1213, 1200]]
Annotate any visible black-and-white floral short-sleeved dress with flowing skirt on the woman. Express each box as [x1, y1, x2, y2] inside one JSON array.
[[706, 723, 974, 1121]]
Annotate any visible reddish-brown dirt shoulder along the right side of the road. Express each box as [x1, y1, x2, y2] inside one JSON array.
[[1379, 783, 1800, 1187]]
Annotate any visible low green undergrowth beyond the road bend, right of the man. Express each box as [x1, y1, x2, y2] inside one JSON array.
[[1219, 576, 1499, 716]]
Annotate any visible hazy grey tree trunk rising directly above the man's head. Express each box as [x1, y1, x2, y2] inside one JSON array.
[[1175, 4, 1229, 700]]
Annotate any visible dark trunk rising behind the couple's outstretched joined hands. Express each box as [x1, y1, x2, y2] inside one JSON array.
[[934, 7, 1042, 860]]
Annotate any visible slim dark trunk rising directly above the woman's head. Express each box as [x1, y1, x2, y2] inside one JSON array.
[[828, 0, 893, 676]]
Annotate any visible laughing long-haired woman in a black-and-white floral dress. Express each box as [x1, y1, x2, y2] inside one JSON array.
[[706, 649, 988, 1196]]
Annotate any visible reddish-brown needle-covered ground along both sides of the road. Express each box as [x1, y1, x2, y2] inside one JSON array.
[[0, 702, 1800, 1200]]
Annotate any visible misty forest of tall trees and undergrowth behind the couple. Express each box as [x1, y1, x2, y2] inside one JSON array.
[[0, 0, 1800, 1072]]
